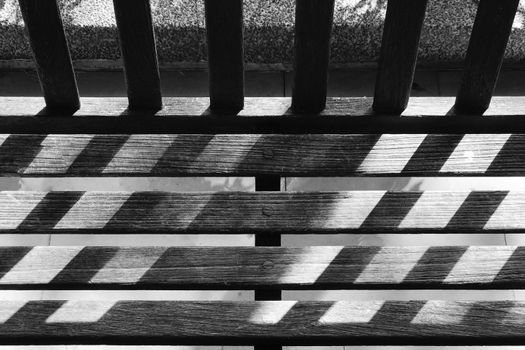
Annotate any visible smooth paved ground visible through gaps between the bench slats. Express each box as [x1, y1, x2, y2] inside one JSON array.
[[0, 70, 525, 350]]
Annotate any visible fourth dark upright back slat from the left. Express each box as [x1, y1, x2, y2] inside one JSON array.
[[292, 0, 334, 113]]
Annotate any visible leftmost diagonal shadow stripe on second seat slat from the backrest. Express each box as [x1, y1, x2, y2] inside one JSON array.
[[18, 191, 84, 231]]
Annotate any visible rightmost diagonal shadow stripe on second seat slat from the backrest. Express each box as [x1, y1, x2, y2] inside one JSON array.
[[447, 191, 508, 230]]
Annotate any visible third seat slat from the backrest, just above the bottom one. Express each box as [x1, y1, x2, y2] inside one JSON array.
[[0, 246, 525, 290]]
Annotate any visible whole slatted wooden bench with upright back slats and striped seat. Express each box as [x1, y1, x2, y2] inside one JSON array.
[[0, 0, 525, 347]]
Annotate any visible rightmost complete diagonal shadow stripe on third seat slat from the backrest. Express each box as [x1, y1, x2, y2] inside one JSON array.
[[402, 246, 467, 288]]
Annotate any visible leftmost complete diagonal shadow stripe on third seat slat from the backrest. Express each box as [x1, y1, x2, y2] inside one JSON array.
[[49, 247, 119, 285]]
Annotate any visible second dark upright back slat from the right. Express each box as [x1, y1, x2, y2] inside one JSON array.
[[373, 0, 427, 114]]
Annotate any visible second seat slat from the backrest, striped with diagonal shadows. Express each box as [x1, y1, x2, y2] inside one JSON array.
[[0, 191, 525, 233]]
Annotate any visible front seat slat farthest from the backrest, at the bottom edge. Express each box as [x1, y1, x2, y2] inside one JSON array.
[[0, 300, 525, 345]]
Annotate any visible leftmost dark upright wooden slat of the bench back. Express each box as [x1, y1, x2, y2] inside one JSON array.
[[19, 0, 80, 111]]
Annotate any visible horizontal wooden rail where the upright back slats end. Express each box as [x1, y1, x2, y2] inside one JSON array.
[[0, 97, 525, 134]]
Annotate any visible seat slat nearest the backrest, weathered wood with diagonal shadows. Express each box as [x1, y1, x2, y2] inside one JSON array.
[[0, 134, 525, 176]]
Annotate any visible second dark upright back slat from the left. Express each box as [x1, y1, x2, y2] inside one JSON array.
[[113, 0, 162, 110]]
